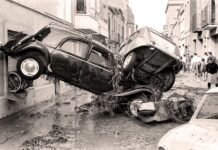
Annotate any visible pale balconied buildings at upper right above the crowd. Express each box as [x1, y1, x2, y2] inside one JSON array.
[[166, 0, 218, 57]]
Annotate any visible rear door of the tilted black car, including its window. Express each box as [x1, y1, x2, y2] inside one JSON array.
[[80, 47, 114, 94]]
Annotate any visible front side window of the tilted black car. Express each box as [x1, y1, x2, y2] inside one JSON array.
[[60, 40, 88, 58]]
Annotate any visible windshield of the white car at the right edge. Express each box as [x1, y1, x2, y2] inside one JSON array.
[[197, 94, 218, 119]]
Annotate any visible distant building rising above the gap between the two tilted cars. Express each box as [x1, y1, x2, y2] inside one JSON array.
[[108, 0, 137, 52]]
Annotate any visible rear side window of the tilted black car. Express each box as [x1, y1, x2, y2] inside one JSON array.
[[88, 48, 113, 68]]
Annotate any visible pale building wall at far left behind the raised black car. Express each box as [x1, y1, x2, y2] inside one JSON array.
[[0, 0, 72, 118]]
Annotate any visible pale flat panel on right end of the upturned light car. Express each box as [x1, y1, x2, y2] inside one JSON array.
[[149, 29, 179, 55]]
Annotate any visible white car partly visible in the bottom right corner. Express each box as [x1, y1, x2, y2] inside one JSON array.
[[158, 88, 218, 150]]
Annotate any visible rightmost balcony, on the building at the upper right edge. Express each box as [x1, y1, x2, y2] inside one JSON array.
[[201, 5, 217, 30]]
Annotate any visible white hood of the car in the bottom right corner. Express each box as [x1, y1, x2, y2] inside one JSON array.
[[159, 121, 218, 150]]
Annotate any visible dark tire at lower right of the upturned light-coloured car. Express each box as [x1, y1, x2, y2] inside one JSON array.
[[161, 70, 176, 92]]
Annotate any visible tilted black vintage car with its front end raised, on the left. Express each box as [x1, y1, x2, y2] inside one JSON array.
[[2, 25, 114, 94]]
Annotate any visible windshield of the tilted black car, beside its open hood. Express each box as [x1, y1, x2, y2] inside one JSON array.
[[37, 28, 72, 47]]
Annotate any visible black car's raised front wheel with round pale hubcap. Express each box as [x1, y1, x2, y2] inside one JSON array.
[[17, 54, 44, 80]]
